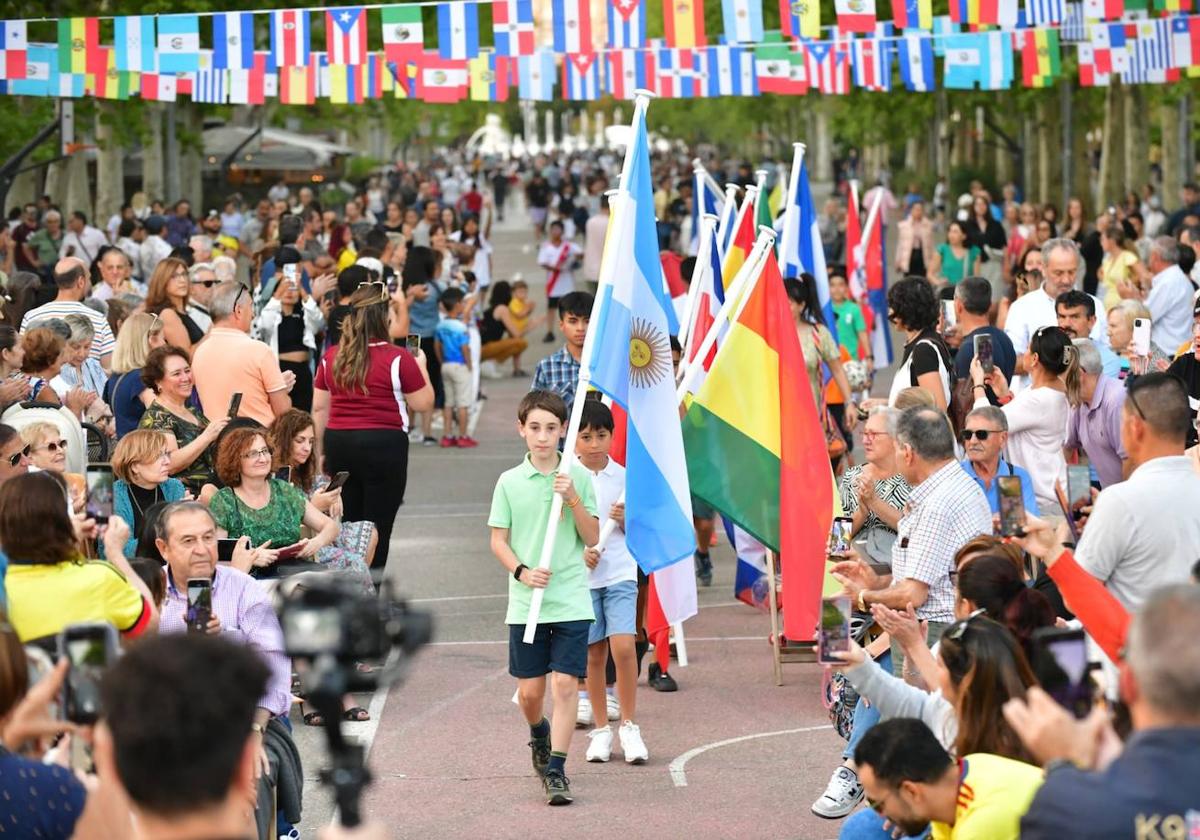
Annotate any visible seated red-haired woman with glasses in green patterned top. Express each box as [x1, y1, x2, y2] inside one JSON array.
[[209, 428, 337, 577]]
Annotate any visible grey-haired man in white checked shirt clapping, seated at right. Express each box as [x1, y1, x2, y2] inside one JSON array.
[[833, 407, 992, 676]]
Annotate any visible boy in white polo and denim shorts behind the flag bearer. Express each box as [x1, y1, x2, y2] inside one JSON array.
[[575, 400, 649, 764]]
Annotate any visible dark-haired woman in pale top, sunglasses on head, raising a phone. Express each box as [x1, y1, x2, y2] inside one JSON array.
[[971, 326, 1080, 521]]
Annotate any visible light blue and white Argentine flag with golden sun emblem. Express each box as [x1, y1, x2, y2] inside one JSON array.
[[588, 110, 696, 574]]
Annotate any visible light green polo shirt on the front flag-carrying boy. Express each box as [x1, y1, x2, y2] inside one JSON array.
[[487, 452, 596, 624]]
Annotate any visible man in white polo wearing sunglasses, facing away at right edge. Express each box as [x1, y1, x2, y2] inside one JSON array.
[[1075, 372, 1200, 612]]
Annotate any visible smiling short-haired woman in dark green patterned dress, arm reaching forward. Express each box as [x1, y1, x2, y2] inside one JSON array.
[[138, 346, 229, 496]]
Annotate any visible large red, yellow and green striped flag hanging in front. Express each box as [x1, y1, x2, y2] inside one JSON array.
[[683, 253, 834, 641]]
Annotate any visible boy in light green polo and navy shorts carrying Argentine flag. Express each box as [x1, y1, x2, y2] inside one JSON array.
[[487, 391, 600, 805]]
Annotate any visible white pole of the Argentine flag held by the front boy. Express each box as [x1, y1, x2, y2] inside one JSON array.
[[523, 90, 654, 644]]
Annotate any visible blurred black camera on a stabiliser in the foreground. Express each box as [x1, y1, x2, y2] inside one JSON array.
[[280, 574, 433, 828]]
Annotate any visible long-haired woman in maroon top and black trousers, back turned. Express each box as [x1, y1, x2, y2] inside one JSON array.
[[312, 282, 433, 565]]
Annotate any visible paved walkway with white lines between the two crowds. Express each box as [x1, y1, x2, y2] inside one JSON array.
[[296, 213, 864, 840]]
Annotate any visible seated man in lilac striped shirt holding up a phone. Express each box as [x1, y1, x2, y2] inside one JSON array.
[[155, 502, 292, 773]]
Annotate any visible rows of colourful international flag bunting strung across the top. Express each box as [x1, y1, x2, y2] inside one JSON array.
[[0, 0, 1200, 104]]
